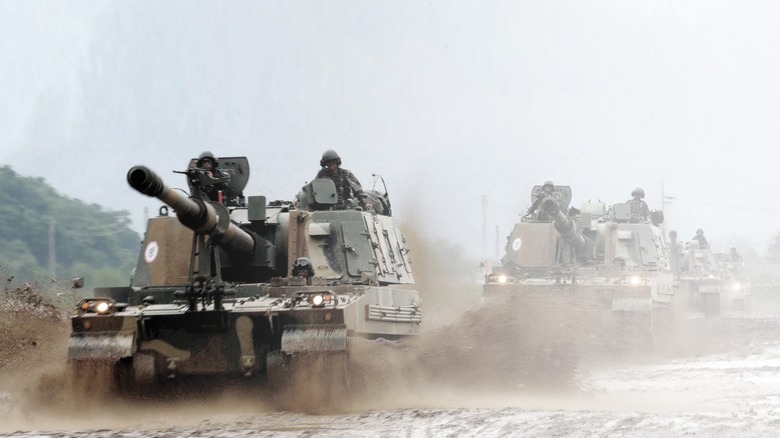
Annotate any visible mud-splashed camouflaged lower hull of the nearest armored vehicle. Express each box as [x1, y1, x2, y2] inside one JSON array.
[[68, 287, 420, 389]]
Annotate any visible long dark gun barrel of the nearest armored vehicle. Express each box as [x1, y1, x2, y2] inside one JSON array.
[[127, 166, 255, 254]]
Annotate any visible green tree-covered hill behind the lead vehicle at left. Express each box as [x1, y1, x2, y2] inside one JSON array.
[[0, 166, 141, 287]]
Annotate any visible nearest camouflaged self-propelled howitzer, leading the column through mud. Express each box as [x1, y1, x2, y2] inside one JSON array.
[[68, 157, 421, 404]]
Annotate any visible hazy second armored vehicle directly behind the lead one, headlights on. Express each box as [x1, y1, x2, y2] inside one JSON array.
[[483, 186, 674, 350]]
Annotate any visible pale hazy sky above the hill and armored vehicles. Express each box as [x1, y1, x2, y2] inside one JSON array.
[[0, 0, 780, 256]]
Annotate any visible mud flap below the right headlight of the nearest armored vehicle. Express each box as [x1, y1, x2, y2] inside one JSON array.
[[281, 325, 347, 354]]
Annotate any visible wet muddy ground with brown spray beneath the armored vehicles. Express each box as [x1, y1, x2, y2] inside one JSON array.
[[0, 280, 780, 437]]
